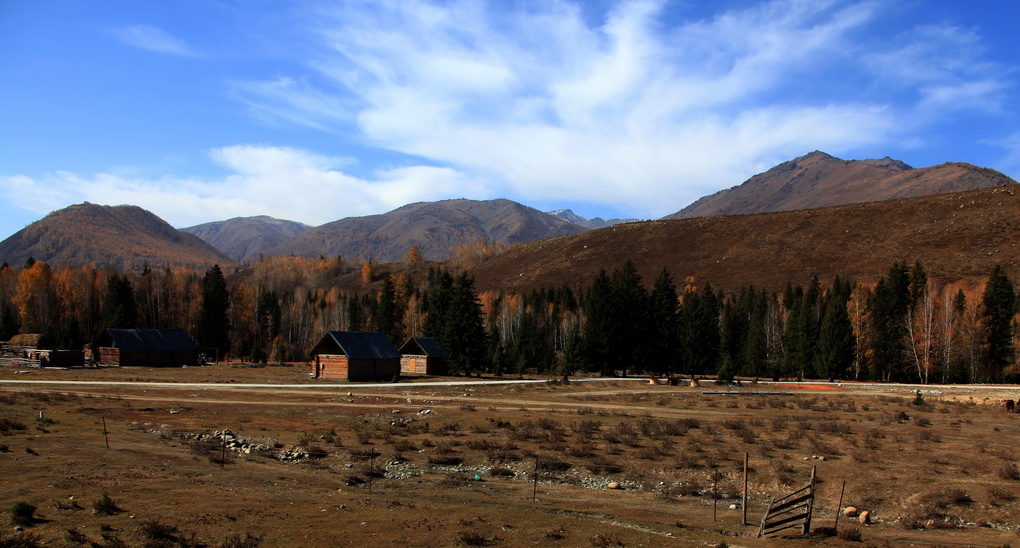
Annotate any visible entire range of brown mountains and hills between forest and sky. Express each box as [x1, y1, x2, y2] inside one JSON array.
[[0, 151, 1015, 287]]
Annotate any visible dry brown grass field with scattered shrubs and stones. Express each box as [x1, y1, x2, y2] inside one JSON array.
[[0, 365, 1020, 547]]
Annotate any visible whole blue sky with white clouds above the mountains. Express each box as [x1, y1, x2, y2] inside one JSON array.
[[0, 0, 1020, 239]]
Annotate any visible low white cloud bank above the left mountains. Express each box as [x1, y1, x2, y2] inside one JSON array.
[[0, 145, 488, 227]]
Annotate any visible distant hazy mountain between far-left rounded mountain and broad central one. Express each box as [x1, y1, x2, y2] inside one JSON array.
[[181, 215, 311, 261]]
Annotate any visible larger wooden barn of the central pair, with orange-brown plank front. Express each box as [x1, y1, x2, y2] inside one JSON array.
[[311, 331, 400, 382]]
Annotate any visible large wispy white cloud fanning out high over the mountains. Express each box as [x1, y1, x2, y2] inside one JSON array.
[[219, 0, 1002, 216]]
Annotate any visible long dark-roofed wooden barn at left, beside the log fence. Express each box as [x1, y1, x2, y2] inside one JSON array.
[[92, 330, 199, 367]]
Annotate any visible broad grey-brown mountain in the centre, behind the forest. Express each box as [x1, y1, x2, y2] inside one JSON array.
[[267, 200, 585, 262]]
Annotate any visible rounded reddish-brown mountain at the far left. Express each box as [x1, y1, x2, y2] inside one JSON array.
[[0, 202, 232, 270]]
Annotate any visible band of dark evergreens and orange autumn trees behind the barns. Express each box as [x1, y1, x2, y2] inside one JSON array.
[[0, 253, 1020, 384]]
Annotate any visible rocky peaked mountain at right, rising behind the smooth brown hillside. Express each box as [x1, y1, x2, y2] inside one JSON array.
[[663, 151, 1016, 219]]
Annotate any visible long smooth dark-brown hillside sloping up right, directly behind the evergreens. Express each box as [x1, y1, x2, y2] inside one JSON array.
[[473, 187, 1020, 291]]
